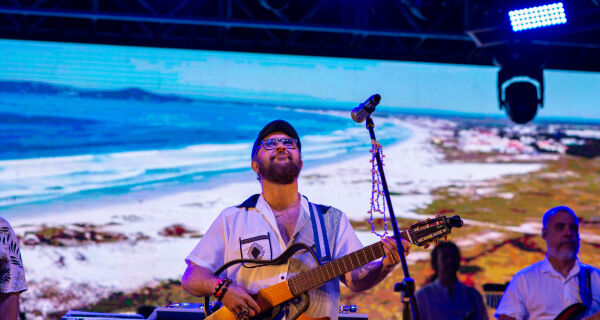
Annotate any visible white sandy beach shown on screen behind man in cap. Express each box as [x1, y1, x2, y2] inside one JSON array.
[[10, 118, 541, 312]]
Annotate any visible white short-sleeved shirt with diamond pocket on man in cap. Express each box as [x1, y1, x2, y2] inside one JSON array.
[[186, 195, 362, 319]]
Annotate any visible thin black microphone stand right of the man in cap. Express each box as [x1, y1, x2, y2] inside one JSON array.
[[366, 116, 421, 320]]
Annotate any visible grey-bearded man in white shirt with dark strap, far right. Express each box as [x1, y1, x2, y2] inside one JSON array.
[[495, 206, 600, 320]]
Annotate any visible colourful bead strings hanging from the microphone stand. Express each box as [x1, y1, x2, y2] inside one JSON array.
[[367, 140, 388, 238]]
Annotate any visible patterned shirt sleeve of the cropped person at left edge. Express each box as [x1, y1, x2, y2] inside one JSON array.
[[0, 218, 27, 293]]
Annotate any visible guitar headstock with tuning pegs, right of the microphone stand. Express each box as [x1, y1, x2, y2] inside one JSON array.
[[406, 216, 463, 248]]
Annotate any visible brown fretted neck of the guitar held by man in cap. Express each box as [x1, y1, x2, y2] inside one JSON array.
[[288, 231, 410, 296]]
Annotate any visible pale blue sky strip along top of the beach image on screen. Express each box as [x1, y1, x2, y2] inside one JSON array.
[[0, 40, 600, 119]]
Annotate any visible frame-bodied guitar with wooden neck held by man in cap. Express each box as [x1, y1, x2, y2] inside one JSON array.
[[206, 216, 463, 320]]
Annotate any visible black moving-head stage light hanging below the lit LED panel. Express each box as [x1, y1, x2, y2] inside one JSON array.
[[498, 64, 544, 124]]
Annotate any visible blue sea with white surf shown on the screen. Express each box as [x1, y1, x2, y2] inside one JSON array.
[[0, 92, 410, 213]]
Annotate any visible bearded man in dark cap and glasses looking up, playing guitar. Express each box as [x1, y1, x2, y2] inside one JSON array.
[[182, 120, 410, 319]]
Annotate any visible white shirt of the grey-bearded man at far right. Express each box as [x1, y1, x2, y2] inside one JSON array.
[[494, 257, 600, 320]]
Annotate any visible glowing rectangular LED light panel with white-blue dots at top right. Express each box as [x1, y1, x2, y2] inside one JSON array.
[[508, 2, 567, 32]]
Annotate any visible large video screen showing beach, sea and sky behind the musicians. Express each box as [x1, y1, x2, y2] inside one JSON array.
[[0, 40, 600, 319]]
